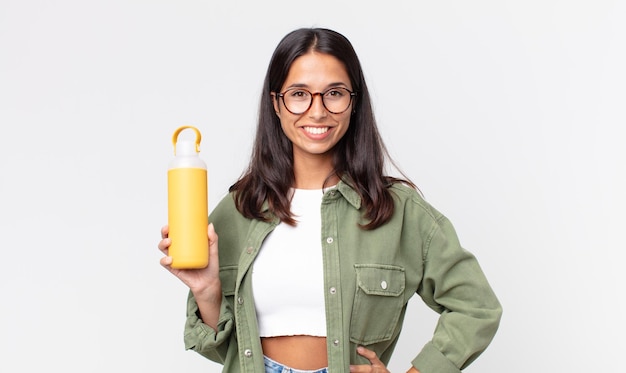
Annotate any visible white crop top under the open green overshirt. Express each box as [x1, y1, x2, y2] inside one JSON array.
[[252, 189, 326, 337]]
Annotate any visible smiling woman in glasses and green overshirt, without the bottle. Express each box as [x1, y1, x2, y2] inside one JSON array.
[[159, 29, 501, 373]]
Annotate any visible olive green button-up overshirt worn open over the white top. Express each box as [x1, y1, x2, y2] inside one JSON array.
[[185, 182, 502, 373]]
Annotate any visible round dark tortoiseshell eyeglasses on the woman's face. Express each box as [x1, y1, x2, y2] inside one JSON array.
[[276, 87, 356, 115]]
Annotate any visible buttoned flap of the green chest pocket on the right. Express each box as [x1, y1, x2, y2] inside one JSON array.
[[354, 264, 405, 297]]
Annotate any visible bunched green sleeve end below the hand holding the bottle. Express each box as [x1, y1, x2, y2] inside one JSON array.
[[185, 292, 235, 364]]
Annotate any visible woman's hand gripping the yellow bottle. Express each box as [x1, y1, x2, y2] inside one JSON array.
[[158, 224, 221, 301]]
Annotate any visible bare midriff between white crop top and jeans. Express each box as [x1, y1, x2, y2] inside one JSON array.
[[261, 335, 328, 370]]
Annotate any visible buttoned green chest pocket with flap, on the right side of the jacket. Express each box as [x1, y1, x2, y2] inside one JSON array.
[[350, 264, 405, 345]]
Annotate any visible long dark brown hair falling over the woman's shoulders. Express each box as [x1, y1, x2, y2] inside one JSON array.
[[229, 28, 415, 229]]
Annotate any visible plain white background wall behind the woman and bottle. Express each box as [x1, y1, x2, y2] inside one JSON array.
[[0, 0, 626, 373]]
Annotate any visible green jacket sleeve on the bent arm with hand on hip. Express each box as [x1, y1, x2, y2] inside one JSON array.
[[412, 216, 502, 373]]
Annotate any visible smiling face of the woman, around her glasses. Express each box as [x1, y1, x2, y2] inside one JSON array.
[[273, 52, 353, 161]]
